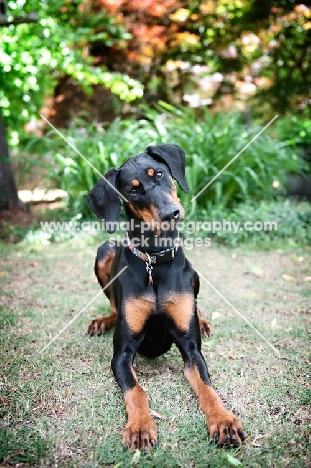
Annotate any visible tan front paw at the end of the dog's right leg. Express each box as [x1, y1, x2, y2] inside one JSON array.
[[208, 409, 247, 447]]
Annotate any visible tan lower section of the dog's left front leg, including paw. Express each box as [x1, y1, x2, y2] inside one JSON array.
[[123, 383, 157, 450]]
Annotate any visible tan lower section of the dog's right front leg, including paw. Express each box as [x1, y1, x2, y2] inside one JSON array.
[[184, 366, 246, 445]]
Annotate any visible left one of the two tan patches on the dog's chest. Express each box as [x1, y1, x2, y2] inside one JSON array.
[[124, 296, 155, 333]]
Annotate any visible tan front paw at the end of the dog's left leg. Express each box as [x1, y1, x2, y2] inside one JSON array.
[[122, 414, 157, 453]]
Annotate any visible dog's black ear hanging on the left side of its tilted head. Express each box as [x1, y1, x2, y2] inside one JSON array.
[[87, 169, 121, 234]]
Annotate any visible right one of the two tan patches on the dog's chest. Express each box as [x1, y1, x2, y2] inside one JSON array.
[[162, 293, 194, 331]]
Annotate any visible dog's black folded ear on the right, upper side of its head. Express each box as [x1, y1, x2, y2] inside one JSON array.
[[146, 144, 189, 193]]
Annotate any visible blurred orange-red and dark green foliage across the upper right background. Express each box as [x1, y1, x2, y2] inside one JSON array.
[[94, 0, 311, 114]]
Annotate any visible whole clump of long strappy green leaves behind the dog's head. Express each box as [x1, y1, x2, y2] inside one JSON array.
[[37, 103, 305, 213]]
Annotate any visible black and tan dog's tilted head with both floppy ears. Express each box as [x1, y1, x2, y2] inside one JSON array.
[[88, 144, 189, 233]]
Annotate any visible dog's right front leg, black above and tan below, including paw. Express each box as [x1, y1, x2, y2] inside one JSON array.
[[175, 333, 246, 447]]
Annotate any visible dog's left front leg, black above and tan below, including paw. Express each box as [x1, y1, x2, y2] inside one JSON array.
[[111, 340, 157, 452]]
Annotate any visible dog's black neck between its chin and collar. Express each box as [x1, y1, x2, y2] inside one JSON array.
[[126, 215, 179, 252]]
